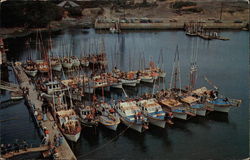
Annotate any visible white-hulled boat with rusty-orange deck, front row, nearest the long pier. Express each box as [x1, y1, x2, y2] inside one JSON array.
[[56, 109, 82, 142]]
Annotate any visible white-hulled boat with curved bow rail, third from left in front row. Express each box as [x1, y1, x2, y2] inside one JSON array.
[[96, 102, 120, 131]]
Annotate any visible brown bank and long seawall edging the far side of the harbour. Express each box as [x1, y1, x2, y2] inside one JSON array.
[[0, 20, 249, 39]]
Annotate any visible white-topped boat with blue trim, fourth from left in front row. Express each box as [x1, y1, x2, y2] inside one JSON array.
[[114, 100, 148, 133]]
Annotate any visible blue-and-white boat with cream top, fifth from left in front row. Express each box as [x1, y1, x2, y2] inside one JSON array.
[[137, 98, 166, 128]]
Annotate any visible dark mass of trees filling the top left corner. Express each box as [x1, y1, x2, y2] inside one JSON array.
[[1, 1, 63, 27]]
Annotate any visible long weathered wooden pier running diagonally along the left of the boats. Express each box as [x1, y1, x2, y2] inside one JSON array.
[[12, 62, 76, 160]]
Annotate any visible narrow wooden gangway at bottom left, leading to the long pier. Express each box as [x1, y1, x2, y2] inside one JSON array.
[[2, 146, 49, 159]]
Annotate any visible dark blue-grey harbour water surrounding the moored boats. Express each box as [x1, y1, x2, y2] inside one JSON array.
[[1, 29, 249, 159]]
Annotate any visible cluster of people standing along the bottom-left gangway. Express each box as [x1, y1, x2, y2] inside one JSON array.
[[1, 140, 28, 155]]
